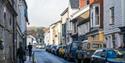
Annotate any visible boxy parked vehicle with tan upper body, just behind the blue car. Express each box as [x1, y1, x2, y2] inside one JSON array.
[[77, 41, 104, 63]]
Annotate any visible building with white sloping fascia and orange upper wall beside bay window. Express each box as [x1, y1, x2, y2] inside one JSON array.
[[70, 0, 90, 41]]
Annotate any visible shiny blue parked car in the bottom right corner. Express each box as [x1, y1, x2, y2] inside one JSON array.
[[91, 48, 125, 63]]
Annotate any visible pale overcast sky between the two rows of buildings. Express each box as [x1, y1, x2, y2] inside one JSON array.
[[26, 0, 68, 27]]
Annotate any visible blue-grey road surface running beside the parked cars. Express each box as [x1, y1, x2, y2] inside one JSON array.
[[30, 49, 73, 63]]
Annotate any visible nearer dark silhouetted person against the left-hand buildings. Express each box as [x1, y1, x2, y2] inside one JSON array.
[[17, 45, 25, 63]]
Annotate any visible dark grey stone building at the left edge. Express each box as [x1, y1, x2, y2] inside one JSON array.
[[0, 0, 17, 63]]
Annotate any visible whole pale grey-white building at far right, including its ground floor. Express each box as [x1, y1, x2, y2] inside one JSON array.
[[104, 0, 125, 48]]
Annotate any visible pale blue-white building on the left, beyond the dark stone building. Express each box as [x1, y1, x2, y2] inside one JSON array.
[[16, 0, 28, 48]]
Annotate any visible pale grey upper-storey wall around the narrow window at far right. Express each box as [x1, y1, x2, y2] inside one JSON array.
[[104, 0, 124, 35]]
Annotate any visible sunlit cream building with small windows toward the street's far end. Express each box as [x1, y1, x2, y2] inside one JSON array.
[[49, 21, 62, 45]]
